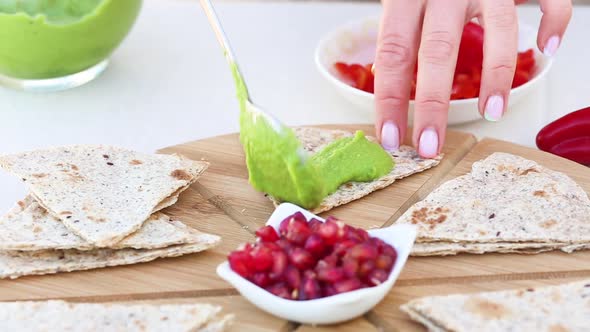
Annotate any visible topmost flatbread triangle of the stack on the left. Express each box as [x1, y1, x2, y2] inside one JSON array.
[[0, 145, 208, 247]]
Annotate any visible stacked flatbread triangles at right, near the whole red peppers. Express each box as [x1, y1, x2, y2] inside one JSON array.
[[396, 152, 590, 256]]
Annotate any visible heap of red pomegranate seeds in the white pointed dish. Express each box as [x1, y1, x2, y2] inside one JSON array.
[[229, 212, 397, 300]]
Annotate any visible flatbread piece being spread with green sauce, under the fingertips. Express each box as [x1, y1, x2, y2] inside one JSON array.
[[269, 127, 442, 214]]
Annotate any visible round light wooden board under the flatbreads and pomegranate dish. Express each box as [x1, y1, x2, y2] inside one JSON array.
[[0, 125, 590, 332]]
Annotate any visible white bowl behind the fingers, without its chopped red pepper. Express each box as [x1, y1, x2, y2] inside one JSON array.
[[315, 17, 552, 124]]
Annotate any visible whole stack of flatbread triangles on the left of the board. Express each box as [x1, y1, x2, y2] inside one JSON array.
[[0, 145, 220, 278]]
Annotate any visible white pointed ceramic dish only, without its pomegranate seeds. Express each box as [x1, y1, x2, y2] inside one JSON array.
[[217, 203, 416, 324]]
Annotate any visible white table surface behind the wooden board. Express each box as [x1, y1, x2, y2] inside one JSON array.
[[0, 0, 590, 211]]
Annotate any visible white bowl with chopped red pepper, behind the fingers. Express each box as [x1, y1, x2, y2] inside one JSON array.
[[315, 17, 552, 125]]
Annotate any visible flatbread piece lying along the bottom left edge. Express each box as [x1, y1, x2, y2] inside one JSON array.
[[0, 300, 233, 332]]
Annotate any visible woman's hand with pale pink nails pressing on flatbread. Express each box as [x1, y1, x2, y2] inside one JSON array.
[[374, 0, 572, 158]]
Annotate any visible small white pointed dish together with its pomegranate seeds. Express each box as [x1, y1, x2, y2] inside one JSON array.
[[217, 203, 416, 324]]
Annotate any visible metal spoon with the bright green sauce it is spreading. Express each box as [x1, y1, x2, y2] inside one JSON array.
[[200, 0, 394, 209]]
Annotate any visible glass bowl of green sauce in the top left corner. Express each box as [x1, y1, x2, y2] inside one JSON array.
[[0, 0, 142, 91]]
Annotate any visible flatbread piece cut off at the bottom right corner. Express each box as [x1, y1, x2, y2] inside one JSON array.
[[401, 280, 590, 332]]
